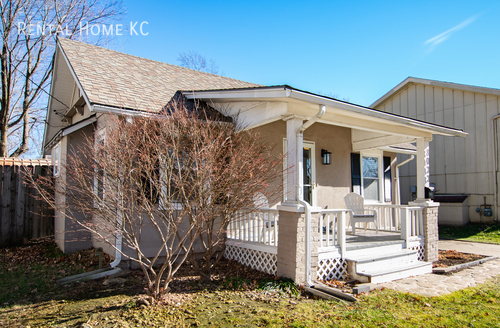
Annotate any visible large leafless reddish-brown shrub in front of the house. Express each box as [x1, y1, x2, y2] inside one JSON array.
[[32, 104, 282, 298]]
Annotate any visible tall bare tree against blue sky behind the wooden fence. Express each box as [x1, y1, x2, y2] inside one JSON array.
[[0, 0, 123, 157]]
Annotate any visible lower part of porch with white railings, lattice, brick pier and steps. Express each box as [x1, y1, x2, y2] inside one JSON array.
[[225, 205, 432, 283]]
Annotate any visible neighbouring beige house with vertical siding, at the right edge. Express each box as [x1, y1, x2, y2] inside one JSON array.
[[371, 77, 500, 225]]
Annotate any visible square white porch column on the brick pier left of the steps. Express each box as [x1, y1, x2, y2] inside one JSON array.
[[286, 116, 304, 203]]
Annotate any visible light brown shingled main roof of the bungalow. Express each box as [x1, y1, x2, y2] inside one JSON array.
[[59, 38, 260, 111]]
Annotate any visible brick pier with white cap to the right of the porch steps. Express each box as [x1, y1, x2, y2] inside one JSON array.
[[408, 199, 439, 262]]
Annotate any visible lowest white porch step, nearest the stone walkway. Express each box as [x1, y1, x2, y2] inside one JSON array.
[[357, 261, 432, 284]]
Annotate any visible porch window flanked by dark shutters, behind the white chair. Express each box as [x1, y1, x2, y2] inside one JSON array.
[[351, 152, 392, 202]]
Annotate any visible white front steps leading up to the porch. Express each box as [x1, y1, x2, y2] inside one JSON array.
[[347, 247, 432, 284]]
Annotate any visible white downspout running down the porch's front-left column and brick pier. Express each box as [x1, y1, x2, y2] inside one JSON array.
[[295, 105, 326, 286]]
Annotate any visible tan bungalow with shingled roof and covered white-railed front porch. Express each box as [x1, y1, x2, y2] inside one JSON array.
[[43, 39, 466, 284]]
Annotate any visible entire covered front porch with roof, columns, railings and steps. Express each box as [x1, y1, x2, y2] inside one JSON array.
[[184, 86, 466, 285]]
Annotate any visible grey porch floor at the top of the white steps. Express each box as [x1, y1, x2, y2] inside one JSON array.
[[346, 229, 404, 250]]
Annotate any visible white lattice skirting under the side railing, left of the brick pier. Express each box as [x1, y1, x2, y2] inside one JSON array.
[[224, 245, 278, 275]]
